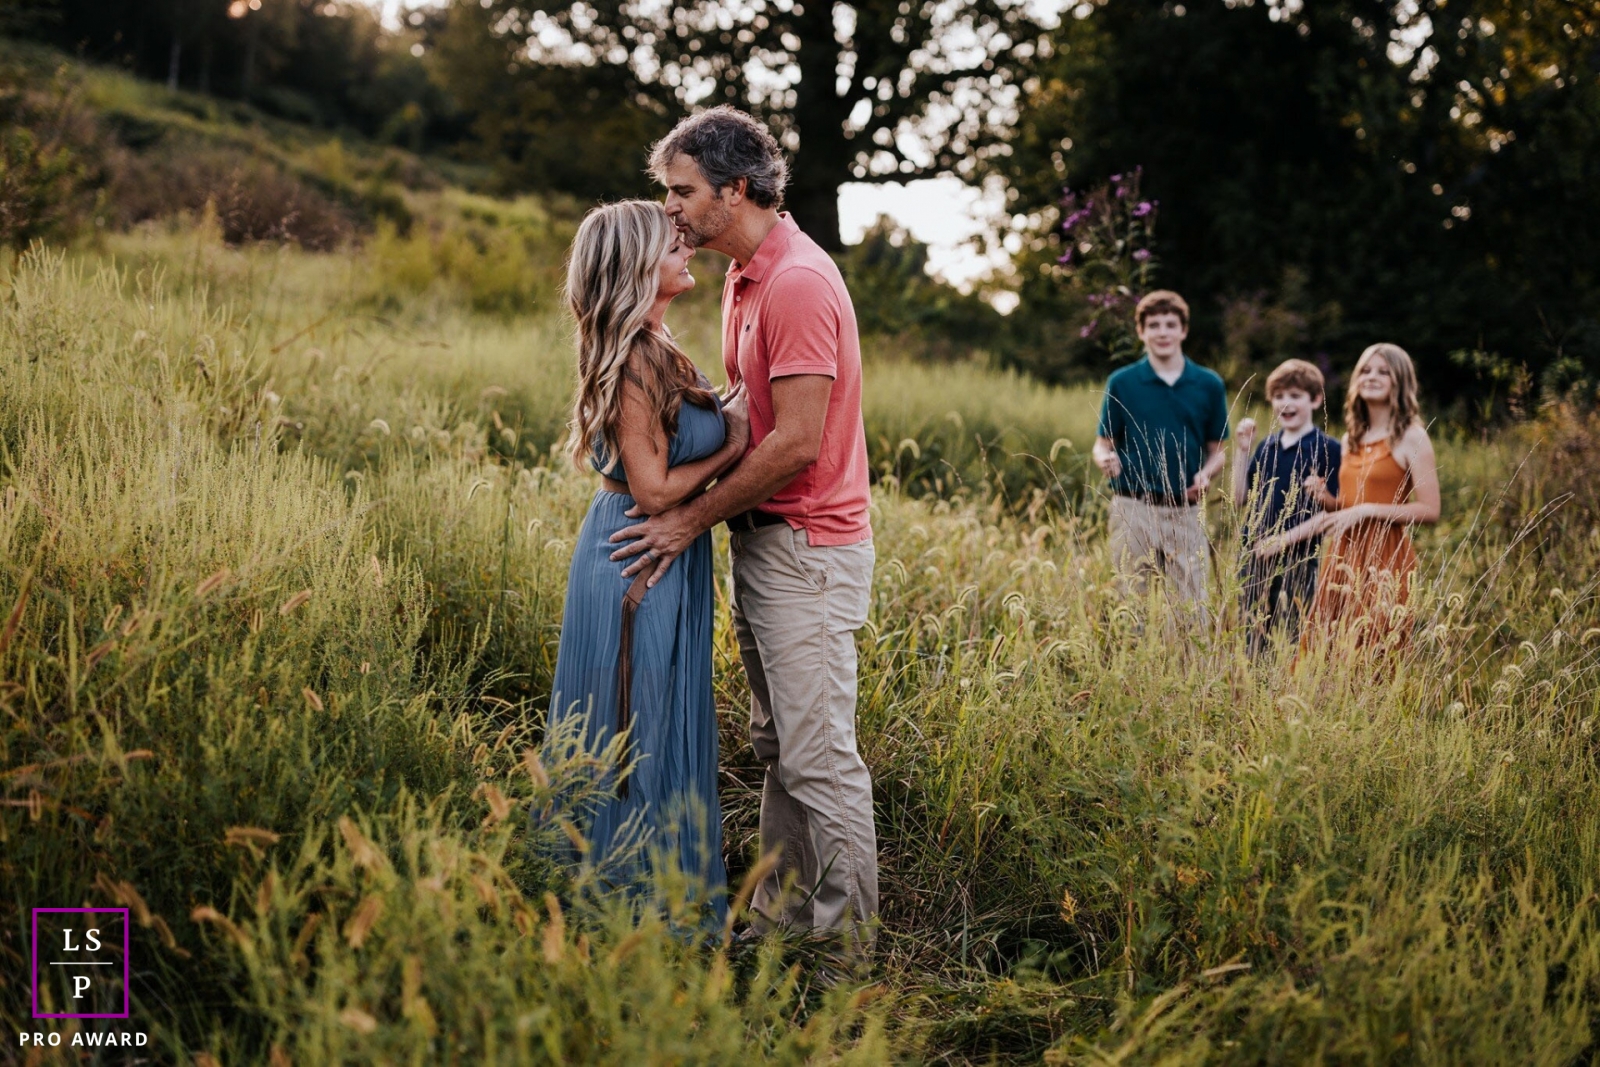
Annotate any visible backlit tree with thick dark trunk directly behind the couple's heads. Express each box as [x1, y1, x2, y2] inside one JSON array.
[[451, 0, 1040, 251]]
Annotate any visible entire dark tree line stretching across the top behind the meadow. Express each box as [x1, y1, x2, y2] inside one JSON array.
[[0, 0, 1600, 411]]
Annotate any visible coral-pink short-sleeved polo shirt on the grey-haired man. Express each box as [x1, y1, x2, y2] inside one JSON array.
[[722, 211, 872, 545]]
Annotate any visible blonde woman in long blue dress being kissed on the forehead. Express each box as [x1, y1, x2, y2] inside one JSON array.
[[549, 200, 749, 920]]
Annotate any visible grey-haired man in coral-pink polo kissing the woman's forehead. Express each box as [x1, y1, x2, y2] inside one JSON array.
[[611, 106, 878, 941]]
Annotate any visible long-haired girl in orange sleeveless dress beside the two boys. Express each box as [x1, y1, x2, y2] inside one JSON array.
[[1283, 344, 1438, 645]]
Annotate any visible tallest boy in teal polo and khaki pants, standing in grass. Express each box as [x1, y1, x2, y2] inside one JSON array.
[[1094, 290, 1227, 621]]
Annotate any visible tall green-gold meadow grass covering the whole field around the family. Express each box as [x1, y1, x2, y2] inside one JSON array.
[[0, 227, 1600, 1064]]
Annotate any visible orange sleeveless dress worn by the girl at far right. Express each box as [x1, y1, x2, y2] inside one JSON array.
[[1307, 438, 1416, 645]]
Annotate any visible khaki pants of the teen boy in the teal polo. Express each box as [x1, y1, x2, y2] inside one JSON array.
[[1110, 496, 1211, 624]]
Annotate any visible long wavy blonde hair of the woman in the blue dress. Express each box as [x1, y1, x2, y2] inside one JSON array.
[[566, 200, 717, 470]]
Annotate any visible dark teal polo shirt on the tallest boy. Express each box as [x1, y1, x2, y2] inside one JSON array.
[[1098, 354, 1227, 496]]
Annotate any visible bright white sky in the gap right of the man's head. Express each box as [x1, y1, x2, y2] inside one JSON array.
[[360, 0, 1005, 292]]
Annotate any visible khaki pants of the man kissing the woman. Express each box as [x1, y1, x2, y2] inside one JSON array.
[[733, 523, 878, 937]]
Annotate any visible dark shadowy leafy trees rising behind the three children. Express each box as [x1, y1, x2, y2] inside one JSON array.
[[990, 0, 1600, 397]]
